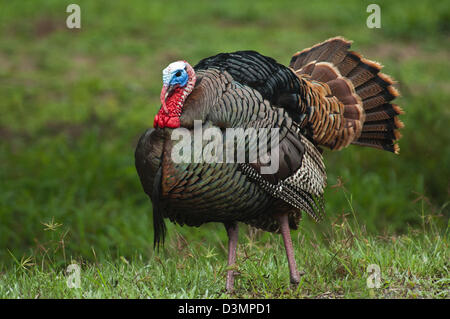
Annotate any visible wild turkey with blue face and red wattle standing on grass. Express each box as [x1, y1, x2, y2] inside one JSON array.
[[135, 37, 403, 291]]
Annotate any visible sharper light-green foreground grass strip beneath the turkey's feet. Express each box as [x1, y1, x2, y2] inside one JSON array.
[[0, 189, 450, 298]]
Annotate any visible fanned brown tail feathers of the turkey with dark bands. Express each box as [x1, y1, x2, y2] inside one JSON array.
[[290, 37, 403, 153]]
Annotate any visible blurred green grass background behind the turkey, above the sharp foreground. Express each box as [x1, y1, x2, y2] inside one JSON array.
[[0, 0, 450, 264]]
